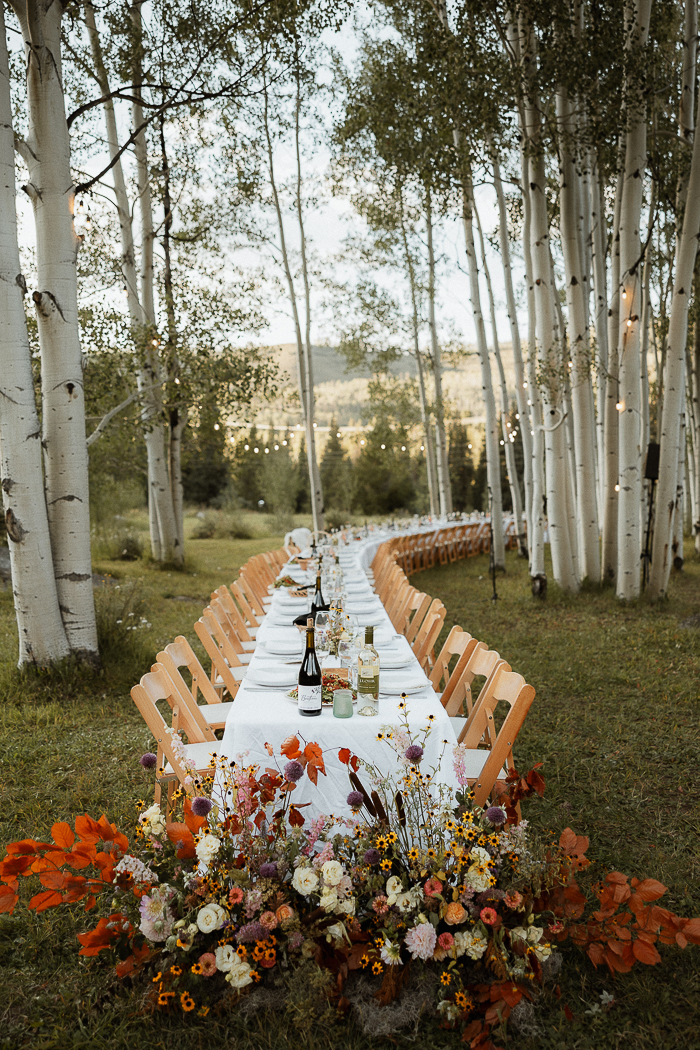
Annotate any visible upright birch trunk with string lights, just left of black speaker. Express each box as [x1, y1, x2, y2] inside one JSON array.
[[616, 0, 652, 601]]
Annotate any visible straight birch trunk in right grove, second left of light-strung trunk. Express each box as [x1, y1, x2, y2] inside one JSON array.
[[556, 88, 600, 584]]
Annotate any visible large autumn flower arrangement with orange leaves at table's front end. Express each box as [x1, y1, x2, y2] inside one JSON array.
[[0, 720, 700, 1050]]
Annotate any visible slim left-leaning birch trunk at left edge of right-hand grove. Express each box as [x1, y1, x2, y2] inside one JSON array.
[[462, 169, 506, 569]]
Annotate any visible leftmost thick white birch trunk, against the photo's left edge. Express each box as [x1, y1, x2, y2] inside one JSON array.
[[0, 7, 70, 667]]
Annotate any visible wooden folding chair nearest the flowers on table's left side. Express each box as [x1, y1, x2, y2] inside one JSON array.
[[131, 671, 219, 819]]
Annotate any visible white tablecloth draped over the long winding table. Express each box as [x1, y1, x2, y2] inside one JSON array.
[[220, 526, 457, 821]]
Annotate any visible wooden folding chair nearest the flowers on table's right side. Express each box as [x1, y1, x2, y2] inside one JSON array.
[[460, 664, 535, 806]]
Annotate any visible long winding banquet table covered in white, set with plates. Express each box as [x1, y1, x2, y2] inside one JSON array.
[[220, 526, 457, 822]]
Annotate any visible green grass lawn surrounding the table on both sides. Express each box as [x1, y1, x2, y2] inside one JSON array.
[[0, 533, 700, 1050]]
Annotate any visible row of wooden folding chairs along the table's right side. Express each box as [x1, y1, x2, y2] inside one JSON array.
[[373, 528, 535, 805]]
